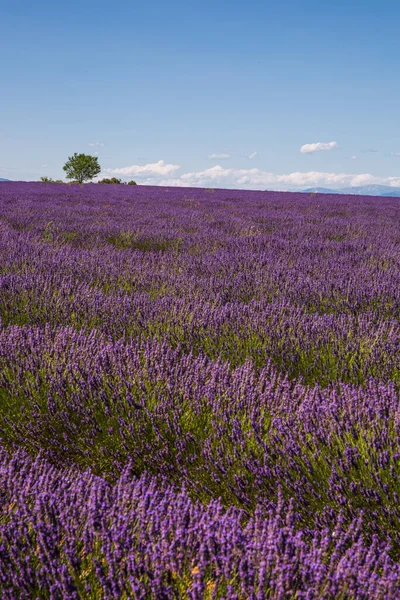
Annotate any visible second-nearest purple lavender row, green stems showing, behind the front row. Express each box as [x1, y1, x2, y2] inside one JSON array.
[[0, 327, 400, 556]]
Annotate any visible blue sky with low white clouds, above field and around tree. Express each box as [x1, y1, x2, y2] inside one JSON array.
[[0, 0, 400, 189]]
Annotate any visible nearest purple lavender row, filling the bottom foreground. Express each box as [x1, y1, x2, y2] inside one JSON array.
[[0, 452, 400, 600]]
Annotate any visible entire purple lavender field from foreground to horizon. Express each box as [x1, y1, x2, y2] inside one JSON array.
[[0, 183, 400, 600]]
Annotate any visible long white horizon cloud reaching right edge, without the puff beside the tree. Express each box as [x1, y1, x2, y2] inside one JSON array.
[[159, 165, 400, 190]]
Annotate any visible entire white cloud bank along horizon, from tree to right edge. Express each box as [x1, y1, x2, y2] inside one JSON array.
[[99, 160, 400, 190]]
